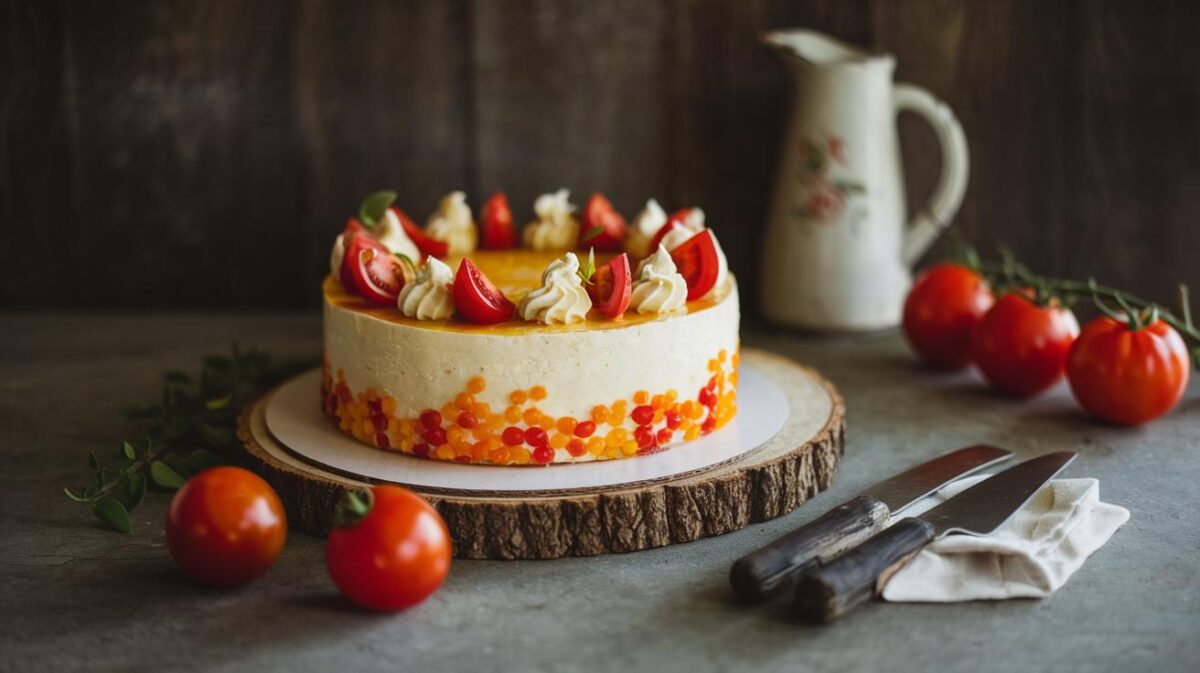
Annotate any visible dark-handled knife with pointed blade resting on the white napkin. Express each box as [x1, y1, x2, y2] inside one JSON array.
[[796, 451, 1075, 624]]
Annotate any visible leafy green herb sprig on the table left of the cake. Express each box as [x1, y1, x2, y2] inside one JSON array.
[[62, 343, 314, 533]]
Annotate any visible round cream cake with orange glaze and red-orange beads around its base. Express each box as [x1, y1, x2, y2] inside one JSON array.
[[322, 189, 739, 465]]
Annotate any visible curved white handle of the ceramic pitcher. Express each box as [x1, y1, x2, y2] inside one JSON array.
[[892, 84, 971, 266]]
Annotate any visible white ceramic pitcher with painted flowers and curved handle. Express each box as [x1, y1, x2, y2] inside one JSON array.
[[761, 30, 968, 331]]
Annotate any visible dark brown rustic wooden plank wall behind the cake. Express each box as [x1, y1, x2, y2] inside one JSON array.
[[0, 0, 1200, 308]]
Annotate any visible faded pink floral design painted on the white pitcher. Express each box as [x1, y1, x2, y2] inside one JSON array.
[[796, 136, 866, 224]]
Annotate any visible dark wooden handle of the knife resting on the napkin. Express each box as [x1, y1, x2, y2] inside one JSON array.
[[796, 518, 935, 624]]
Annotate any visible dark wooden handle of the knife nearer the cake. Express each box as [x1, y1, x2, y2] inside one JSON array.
[[730, 495, 890, 602]]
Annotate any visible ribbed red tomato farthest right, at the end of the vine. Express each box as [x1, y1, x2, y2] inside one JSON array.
[[1067, 316, 1192, 426]]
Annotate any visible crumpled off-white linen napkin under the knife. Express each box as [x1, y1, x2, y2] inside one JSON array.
[[883, 476, 1129, 602]]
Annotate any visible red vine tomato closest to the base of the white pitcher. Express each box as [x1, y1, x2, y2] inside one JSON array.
[[904, 264, 996, 369]]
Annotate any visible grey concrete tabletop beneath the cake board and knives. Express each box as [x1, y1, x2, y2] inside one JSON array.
[[0, 314, 1200, 673]]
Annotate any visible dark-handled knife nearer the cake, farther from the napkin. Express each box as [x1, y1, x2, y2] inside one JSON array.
[[730, 444, 1013, 602]]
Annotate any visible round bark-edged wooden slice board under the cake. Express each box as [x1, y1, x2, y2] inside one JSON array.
[[238, 349, 845, 559]]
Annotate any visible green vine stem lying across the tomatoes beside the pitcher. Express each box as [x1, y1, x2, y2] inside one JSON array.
[[964, 252, 1200, 368]]
